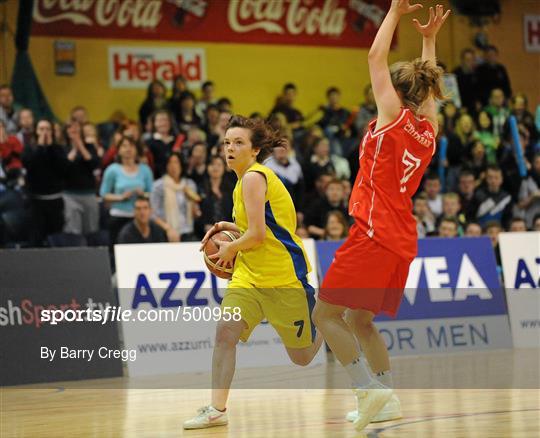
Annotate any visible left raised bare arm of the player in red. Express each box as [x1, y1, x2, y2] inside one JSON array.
[[368, 0, 422, 128]]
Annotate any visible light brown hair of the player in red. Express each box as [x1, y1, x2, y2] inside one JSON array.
[[390, 58, 444, 112]]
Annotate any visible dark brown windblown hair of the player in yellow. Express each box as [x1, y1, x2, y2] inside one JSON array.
[[226, 116, 288, 163]]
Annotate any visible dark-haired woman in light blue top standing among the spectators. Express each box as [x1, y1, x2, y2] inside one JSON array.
[[99, 136, 153, 245]]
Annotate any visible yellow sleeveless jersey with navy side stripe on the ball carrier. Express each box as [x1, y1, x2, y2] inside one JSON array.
[[233, 163, 311, 288]]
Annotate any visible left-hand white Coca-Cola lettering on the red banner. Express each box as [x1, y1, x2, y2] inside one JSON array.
[[34, 0, 162, 29]]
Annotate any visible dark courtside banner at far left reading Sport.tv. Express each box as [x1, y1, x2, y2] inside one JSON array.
[[0, 248, 122, 385]]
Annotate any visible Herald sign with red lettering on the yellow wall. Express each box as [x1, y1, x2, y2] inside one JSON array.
[[109, 47, 206, 88]]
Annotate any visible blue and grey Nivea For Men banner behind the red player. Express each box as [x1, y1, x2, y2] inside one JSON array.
[[317, 237, 512, 354]]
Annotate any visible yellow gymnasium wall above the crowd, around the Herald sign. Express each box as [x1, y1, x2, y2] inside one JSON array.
[[1, 0, 540, 120]]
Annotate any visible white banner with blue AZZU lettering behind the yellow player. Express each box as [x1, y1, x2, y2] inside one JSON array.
[[115, 240, 325, 376]]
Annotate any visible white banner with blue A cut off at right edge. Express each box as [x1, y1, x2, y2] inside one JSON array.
[[499, 232, 540, 348]]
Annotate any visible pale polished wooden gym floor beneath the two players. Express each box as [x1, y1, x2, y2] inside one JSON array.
[[0, 350, 540, 438]]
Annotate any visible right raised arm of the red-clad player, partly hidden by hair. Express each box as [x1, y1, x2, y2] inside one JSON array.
[[413, 5, 450, 134]]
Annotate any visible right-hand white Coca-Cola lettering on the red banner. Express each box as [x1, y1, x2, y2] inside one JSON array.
[[227, 0, 347, 36]]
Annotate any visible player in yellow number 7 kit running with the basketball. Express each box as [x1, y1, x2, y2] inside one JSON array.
[[184, 116, 322, 429]]
